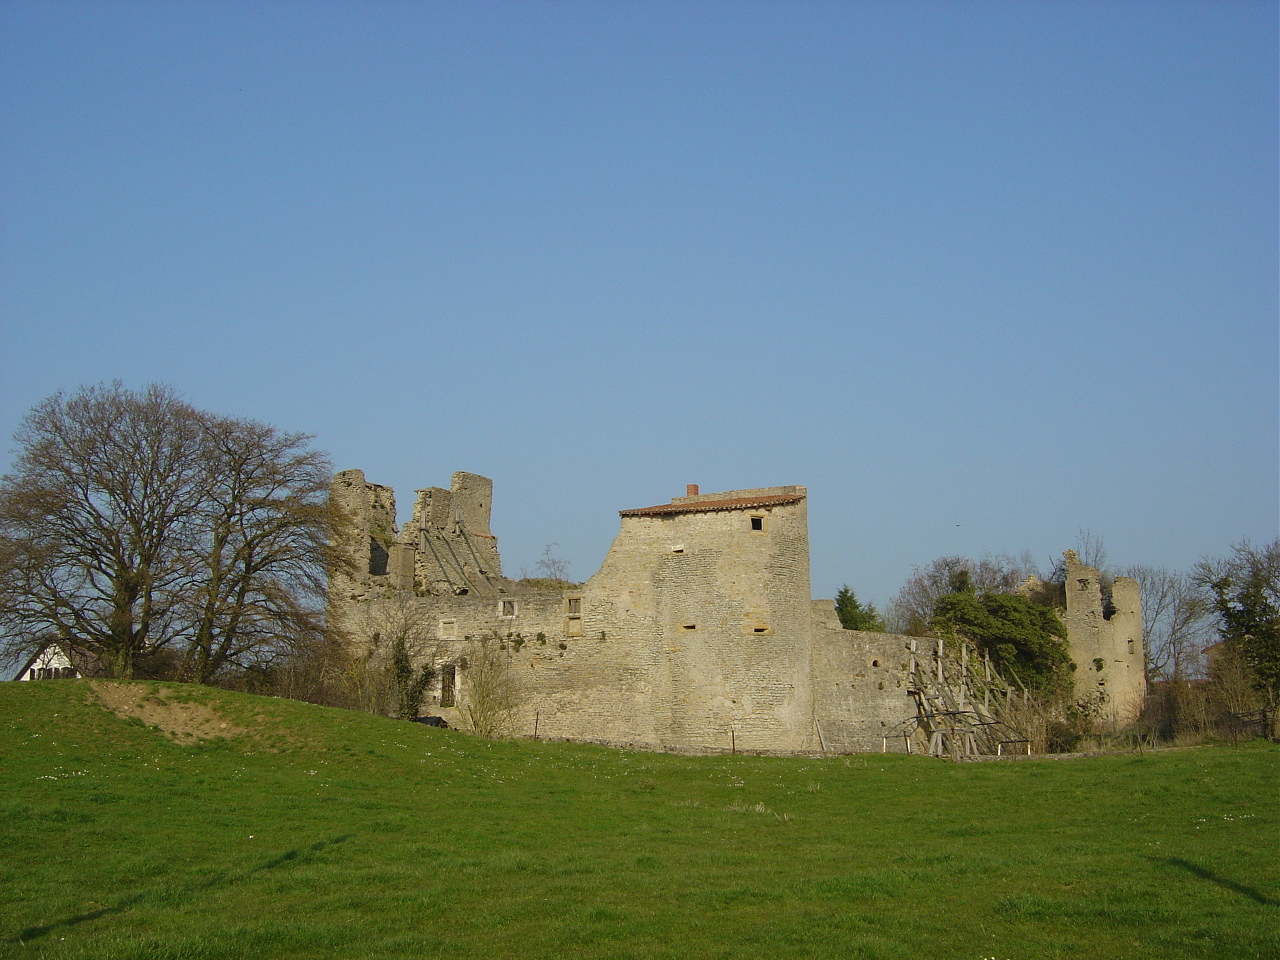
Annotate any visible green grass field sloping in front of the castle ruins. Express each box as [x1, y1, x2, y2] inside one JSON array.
[[0, 681, 1280, 960]]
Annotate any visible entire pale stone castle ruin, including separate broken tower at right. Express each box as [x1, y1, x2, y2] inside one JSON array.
[[329, 470, 1143, 753]]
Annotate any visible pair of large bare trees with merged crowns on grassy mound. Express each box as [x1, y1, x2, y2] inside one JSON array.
[[0, 383, 335, 681]]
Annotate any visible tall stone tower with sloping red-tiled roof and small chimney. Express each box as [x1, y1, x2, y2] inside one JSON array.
[[586, 485, 813, 750]]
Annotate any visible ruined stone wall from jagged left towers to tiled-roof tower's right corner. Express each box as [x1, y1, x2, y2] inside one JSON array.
[[330, 471, 818, 750]]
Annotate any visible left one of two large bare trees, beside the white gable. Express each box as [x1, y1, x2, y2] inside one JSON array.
[[0, 384, 201, 677]]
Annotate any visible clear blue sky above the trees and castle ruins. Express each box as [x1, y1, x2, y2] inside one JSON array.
[[0, 0, 1280, 603]]
